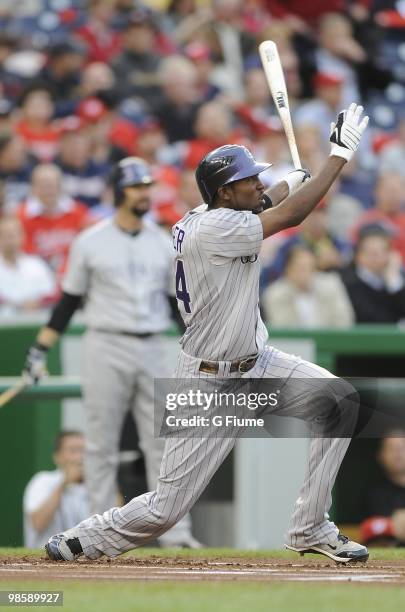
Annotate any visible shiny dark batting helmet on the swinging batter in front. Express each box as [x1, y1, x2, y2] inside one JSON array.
[[195, 145, 271, 204]]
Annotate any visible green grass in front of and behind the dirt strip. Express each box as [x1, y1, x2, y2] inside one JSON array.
[[0, 548, 405, 612]]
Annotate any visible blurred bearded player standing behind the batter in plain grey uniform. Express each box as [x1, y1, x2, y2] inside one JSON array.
[[24, 157, 199, 547]]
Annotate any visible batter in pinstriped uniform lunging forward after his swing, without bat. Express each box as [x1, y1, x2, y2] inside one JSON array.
[[46, 104, 368, 563]]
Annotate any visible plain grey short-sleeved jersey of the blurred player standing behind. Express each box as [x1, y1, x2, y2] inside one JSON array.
[[62, 219, 174, 333]]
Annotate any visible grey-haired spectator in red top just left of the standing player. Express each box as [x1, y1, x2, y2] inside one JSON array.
[[16, 164, 92, 273]]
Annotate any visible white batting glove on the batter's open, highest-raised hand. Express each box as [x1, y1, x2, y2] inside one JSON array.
[[330, 103, 368, 161]]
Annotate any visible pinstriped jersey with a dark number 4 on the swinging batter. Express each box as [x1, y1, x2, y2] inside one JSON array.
[[173, 204, 268, 361]]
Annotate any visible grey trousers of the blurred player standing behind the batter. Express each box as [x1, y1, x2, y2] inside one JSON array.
[[83, 330, 191, 546]]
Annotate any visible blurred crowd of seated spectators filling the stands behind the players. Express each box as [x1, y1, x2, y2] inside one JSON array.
[[0, 0, 405, 327]]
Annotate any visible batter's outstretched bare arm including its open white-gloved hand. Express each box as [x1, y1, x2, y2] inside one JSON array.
[[259, 104, 368, 238]]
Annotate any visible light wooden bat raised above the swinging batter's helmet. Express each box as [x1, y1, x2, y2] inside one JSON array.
[[259, 40, 302, 169]]
